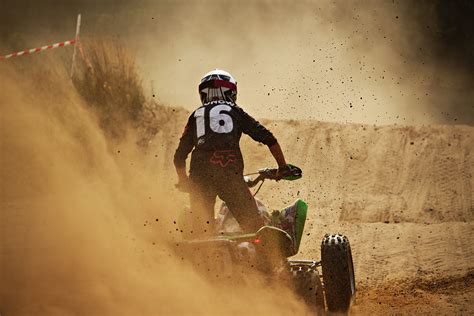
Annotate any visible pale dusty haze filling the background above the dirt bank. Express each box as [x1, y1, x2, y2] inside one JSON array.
[[0, 0, 474, 124]]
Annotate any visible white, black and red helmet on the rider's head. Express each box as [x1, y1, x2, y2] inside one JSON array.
[[199, 69, 237, 104]]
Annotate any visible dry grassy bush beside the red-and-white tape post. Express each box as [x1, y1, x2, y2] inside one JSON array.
[[74, 40, 177, 146]]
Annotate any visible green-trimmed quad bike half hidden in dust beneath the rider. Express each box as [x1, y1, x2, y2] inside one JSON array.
[[175, 165, 355, 314]]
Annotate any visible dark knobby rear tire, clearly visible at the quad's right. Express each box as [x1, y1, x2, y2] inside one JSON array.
[[321, 234, 355, 313]]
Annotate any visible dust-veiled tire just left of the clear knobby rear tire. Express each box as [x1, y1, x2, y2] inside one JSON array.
[[291, 266, 325, 315]]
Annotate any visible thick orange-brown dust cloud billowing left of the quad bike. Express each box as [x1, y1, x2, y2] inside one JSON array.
[[0, 62, 304, 315]]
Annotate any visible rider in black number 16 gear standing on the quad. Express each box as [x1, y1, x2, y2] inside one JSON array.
[[174, 69, 289, 235]]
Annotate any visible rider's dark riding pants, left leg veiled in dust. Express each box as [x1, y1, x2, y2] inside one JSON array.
[[190, 169, 263, 236]]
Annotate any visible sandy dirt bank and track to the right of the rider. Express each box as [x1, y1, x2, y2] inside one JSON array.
[[157, 113, 474, 314]]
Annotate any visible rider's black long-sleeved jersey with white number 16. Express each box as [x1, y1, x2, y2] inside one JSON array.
[[174, 101, 277, 172]]
